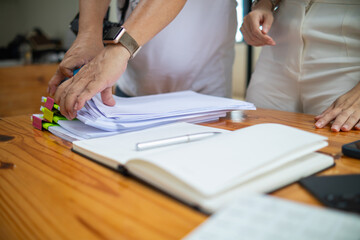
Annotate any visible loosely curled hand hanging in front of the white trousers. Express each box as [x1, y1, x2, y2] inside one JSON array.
[[240, 0, 275, 46]]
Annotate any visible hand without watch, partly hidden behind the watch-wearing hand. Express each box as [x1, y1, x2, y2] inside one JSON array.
[[47, 34, 104, 96]]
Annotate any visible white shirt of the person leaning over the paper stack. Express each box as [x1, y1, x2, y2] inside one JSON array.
[[117, 0, 237, 97]]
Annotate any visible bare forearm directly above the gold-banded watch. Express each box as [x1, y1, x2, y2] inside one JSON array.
[[123, 0, 186, 46]]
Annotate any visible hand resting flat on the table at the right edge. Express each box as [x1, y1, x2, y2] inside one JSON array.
[[315, 82, 360, 132]]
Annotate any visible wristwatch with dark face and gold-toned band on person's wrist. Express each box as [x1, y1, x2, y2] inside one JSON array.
[[103, 27, 141, 58]]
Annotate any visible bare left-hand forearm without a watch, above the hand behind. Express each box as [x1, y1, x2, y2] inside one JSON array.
[[78, 0, 110, 41]]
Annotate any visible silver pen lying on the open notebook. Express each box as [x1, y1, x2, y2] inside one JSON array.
[[135, 132, 221, 151]]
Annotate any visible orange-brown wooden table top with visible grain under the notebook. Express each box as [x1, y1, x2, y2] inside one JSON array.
[[0, 109, 360, 239]]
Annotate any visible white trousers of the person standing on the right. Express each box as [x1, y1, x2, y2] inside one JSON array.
[[246, 0, 360, 114]]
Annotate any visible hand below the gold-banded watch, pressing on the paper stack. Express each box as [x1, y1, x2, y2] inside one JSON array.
[[54, 45, 130, 119]]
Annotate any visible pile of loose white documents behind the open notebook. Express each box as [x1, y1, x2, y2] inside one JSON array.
[[31, 91, 255, 141]]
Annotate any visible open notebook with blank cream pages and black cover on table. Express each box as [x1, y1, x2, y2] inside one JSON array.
[[73, 123, 334, 213]]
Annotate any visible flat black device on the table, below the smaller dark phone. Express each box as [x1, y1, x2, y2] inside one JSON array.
[[299, 174, 360, 214]]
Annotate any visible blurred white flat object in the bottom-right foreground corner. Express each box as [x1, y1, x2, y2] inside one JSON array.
[[183, 195, 360, 240]]
